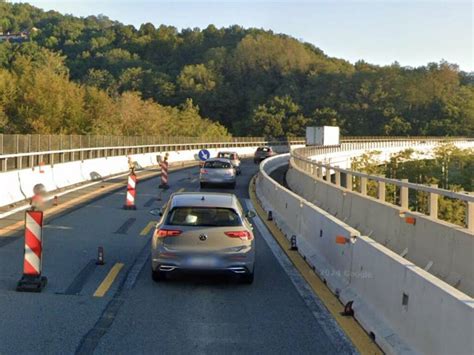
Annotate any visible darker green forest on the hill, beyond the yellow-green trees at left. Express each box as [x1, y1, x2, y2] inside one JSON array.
[[0, 2, 474, 136]]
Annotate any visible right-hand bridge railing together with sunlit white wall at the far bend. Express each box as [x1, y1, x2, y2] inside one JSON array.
[[290, 137, 474, 232]]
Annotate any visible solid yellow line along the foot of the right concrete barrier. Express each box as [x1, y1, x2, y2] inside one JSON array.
[[249, 177, 383, 354]]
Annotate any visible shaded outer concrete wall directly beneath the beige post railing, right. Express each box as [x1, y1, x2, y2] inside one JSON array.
[[287, 159, 474, 297]]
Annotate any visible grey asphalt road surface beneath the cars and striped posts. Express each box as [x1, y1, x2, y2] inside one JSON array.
[[0, 162, 355, 354]]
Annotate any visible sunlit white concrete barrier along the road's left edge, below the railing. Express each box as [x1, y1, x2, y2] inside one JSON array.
[[0, 146, 304, 207]]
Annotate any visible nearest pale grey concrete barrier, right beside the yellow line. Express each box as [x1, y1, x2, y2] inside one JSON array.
[[257, 155, 474, 354]]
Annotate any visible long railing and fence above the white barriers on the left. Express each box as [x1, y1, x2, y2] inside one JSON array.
[[0, 135, 305, 172]]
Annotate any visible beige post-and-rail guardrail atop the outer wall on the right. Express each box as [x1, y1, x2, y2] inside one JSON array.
[[291, 137, 474, 232]]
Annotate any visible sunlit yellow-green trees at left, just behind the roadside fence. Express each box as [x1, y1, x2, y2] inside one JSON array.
[[0, 43, 228, 137]]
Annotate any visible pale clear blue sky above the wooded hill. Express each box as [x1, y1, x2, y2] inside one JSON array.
[[18, 0, 474, 71]]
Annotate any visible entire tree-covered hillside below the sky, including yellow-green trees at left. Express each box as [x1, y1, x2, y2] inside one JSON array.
[[0, 2, 474, 136]]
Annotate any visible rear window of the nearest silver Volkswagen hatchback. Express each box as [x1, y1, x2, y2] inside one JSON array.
[[166, 207, 242, 227]]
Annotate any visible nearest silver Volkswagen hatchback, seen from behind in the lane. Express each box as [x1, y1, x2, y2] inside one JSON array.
[[151, 192, 255, 283]]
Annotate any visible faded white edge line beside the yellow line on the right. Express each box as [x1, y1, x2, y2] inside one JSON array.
[[244, 199, 357, 354]]
